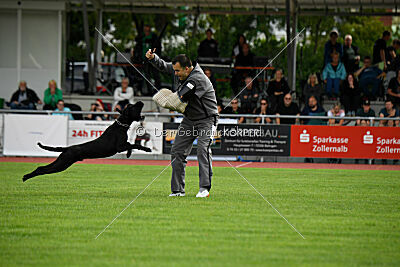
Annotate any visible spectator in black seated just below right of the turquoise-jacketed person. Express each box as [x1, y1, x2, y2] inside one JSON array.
[[340, 73, 361, 116]]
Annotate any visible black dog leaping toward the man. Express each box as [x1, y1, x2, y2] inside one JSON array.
[[22, 101, 151, 182]]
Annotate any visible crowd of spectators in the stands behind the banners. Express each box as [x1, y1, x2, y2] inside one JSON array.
[[9, 25, 400, 126]]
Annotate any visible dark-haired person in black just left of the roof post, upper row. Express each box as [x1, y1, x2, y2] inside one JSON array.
[[267, 69, 290, 113]]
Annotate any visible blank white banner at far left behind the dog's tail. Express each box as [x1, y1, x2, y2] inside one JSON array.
[[3, 114, 68, 157]]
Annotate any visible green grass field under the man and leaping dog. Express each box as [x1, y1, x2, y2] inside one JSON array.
[[0, 163, 400, 266]]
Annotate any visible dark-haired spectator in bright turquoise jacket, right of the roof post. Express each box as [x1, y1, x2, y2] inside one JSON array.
[[322, 53, 346, 99]]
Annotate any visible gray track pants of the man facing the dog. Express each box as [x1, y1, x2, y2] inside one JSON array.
[[171, 117, 218, 193]]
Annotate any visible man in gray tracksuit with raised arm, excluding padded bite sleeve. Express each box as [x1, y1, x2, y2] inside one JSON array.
[[146, 50, 218, 197]]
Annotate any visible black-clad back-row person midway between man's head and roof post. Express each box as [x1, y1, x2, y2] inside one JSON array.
[[231, 43, 254, 94]]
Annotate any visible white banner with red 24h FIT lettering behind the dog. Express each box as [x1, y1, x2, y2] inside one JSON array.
[[68, 121, 163, 154]]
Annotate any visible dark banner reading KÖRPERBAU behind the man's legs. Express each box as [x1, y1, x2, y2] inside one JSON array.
[[163, 123, 290, 156]]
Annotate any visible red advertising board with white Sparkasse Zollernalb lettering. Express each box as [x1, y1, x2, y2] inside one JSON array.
[[290, 125, 400, 159]]
